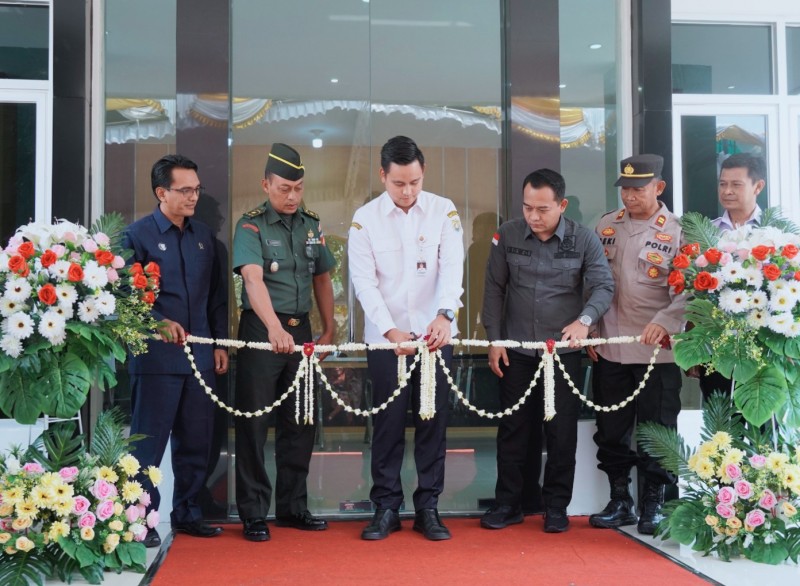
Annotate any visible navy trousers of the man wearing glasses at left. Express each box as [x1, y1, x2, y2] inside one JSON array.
[[131, 370, 215, 523]]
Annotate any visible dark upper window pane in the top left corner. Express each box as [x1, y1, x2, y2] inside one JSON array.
[[0, 6, 50, 79]]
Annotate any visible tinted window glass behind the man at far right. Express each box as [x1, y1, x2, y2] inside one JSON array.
[[681, 116, 769, 219]]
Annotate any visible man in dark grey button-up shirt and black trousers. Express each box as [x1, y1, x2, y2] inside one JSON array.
[[481, 169, 614, 533]]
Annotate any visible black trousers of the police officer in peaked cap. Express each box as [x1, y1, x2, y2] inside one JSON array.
[[592, 356, 681, 484]]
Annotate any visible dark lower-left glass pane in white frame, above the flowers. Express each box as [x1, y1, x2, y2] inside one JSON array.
[[0, 103, 36, 246]]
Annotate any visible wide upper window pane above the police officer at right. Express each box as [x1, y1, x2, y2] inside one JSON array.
[[672, 24, 774, 94]]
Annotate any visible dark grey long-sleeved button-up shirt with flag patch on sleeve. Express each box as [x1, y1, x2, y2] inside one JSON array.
[[481, 216, 614, 355]]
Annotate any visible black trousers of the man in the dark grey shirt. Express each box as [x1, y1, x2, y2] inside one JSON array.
[[495, 350, 582, 507]]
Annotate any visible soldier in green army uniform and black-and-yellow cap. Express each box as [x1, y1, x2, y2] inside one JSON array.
[[233, 143, 336, 541]]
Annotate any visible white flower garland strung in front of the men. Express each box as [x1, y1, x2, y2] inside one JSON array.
[[184, 335, 661, 425]]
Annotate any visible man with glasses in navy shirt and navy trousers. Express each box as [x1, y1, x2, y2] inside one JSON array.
[[123, 155, 228, 547]]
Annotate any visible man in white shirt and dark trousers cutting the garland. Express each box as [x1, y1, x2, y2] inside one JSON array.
[[348, 136, 464, 541]]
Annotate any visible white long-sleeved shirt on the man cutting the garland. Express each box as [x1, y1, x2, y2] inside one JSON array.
[[347, 191, 464, 344]]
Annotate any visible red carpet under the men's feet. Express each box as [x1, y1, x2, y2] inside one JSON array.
[[152, 516, 708, 586]]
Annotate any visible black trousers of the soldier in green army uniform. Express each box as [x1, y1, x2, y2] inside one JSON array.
[[235, 311, 316, 519]]
